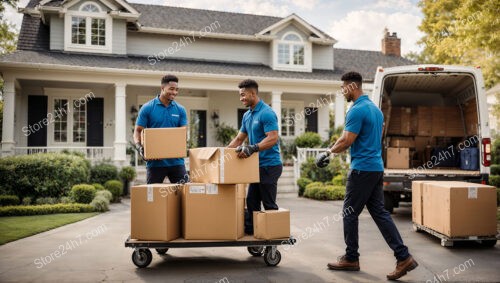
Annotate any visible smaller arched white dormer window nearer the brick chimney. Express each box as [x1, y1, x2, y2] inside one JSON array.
[[273, 31, 311, 72]]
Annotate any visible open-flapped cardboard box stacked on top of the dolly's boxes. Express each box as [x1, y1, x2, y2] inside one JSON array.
[[189, 147, 260, 184]]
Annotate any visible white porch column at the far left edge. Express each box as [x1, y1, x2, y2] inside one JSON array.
[[1, 79, 16, 156]]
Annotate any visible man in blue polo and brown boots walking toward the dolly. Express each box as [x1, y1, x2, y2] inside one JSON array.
[[316, 72, 418, 280]]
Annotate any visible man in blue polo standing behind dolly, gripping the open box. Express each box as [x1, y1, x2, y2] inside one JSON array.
[[228, 79, 283, 235]]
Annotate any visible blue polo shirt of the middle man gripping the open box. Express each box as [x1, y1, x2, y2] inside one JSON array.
[[240, 100, 281, 167]]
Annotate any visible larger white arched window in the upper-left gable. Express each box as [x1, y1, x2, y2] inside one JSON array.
[[65, 2, 112, 53]]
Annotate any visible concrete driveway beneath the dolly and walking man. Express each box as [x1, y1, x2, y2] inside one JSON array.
[[0, 195, 500, 283]]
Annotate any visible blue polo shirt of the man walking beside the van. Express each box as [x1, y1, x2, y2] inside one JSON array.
[[345, 95, 384, 172]]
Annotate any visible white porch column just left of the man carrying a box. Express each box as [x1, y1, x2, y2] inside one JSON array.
[[113, 83, 127, 166]]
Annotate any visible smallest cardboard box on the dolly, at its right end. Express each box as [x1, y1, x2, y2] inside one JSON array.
[[253, 208, 290, 240]]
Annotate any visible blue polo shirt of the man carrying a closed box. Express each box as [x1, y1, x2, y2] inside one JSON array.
[[135, 95, 187, 168]]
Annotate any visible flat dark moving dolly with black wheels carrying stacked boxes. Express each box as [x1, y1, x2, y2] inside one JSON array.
[[125, 235, 297, 268]]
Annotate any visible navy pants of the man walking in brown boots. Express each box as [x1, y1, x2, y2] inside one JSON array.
[[343, 170, 410, 261]]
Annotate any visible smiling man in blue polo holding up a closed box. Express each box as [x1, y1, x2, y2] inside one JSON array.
[[134, 75, 189, 184]]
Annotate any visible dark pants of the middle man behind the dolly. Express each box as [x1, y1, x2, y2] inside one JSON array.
[[245, 165, 283, 234]]
